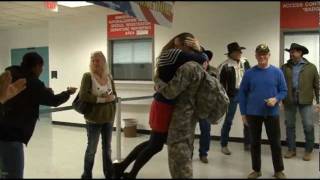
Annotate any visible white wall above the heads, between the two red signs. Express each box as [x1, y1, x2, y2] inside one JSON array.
[[156, 2, 280, 66]]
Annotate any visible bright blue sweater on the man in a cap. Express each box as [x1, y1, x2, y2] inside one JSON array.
[[239, 65, 288, 116]]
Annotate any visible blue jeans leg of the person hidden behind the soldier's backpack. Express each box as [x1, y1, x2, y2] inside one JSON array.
[[199, 119, 211, 157]]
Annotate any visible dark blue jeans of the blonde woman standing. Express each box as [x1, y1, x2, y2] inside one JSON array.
[[82, 122, 113, 178]]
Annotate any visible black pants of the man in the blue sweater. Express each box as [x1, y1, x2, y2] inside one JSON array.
[[247, 116, 284, 172]]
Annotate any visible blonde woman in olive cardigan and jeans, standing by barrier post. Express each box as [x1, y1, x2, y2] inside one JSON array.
[[79, 51, 117, 179]]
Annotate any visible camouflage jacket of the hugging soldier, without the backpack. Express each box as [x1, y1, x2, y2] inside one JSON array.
[[154, 61, 206, 144]]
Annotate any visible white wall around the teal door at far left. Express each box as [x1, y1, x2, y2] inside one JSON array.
[[0, 26, 48, 70]]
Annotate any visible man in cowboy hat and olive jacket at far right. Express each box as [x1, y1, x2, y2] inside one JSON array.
[[282, 43, 319, 161]]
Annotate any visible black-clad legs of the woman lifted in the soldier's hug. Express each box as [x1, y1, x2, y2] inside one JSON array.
[[120, 131, 167, 177]]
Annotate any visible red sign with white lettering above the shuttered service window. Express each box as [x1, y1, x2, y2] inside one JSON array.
[[107, 14, 154, 39]]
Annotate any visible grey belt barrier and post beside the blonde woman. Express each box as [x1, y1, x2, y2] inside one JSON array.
[[40, 96, 153, 162]]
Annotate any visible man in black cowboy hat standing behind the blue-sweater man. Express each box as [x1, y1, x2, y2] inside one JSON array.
[[218, 42, 250, 155]]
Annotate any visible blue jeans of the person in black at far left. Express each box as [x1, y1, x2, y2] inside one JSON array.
[[0, 141, 24, 179]]
